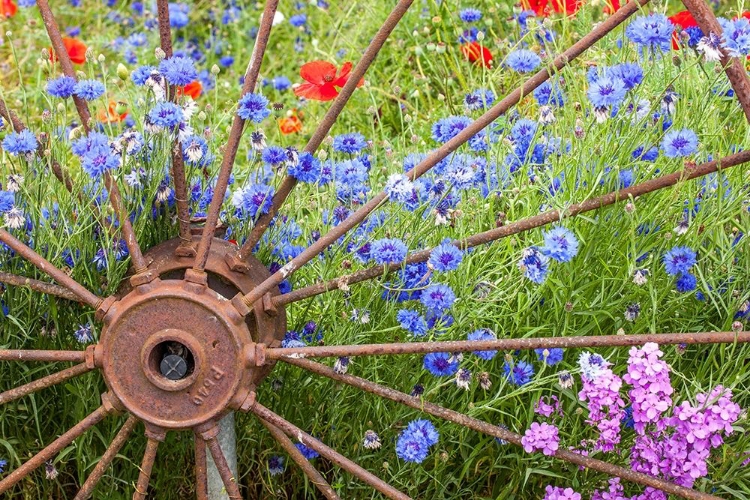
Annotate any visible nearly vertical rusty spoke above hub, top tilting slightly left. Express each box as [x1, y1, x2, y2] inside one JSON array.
[[156, 0, 193, 253]]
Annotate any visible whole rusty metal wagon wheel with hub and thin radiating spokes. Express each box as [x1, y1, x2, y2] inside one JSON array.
[[0, 0, 750, 499]]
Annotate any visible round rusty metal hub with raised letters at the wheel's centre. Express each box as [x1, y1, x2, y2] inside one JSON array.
[[95, 239, 286, 429]]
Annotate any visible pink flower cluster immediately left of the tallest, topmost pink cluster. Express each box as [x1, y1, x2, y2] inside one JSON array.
[[578, 360, 625, 452]]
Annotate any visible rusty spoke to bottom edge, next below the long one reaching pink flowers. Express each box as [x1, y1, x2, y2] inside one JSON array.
[[250, 403, 410, 500]]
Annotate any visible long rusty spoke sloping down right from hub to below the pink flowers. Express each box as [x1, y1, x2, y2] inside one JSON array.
[[283, 358, 720, 500]]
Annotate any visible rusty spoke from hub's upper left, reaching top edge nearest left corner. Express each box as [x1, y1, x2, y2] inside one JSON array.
[[37, 0, 147, 274]]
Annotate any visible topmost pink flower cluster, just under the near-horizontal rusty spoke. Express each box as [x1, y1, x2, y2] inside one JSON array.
[[623, 342, 674, 434]]
